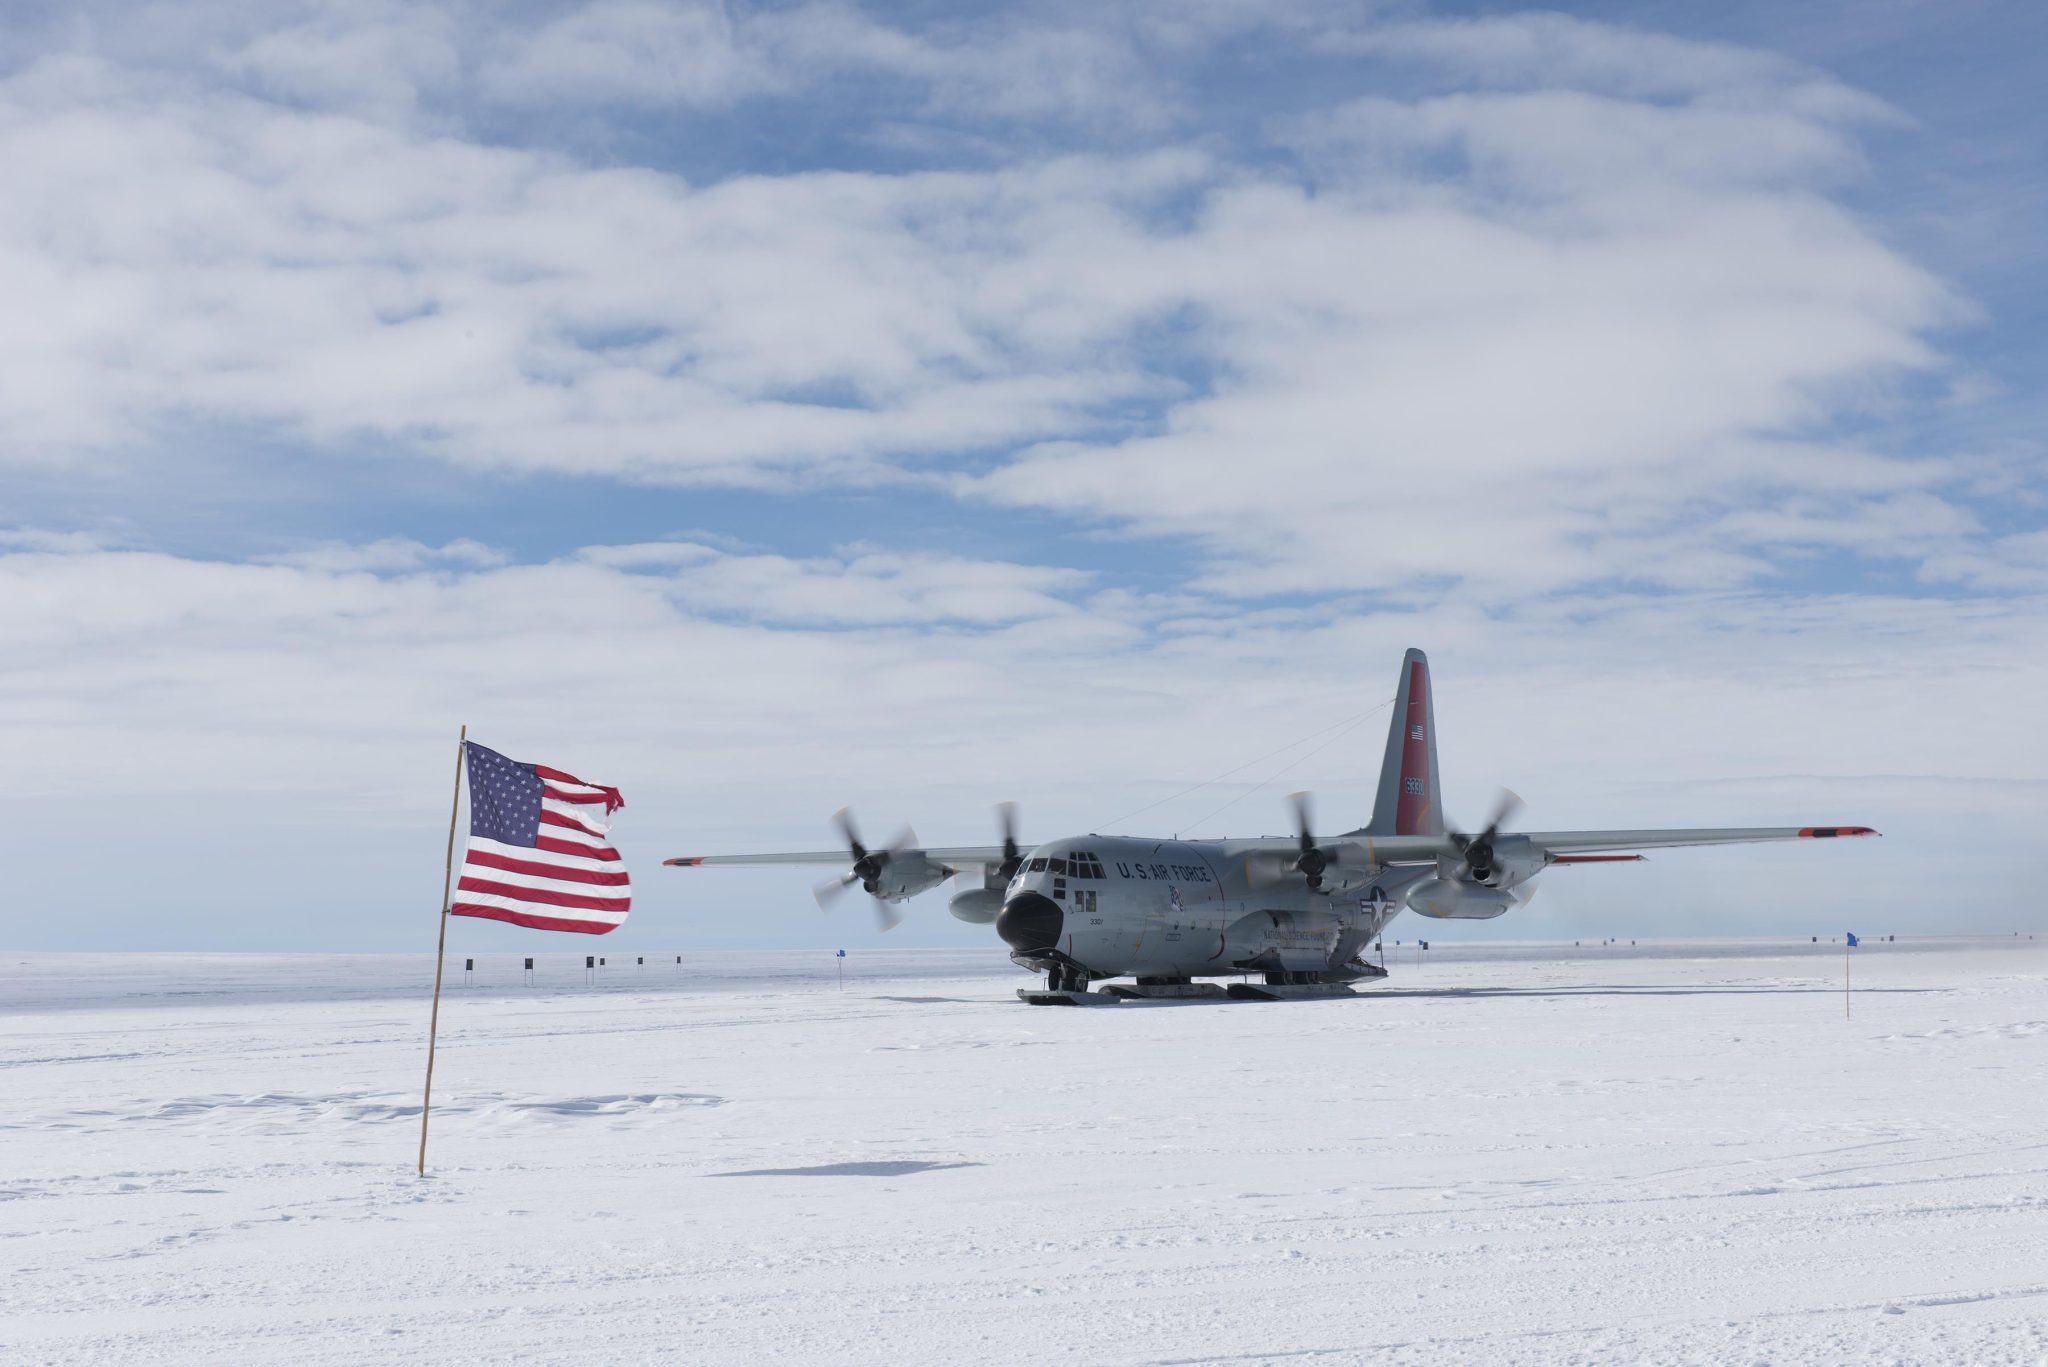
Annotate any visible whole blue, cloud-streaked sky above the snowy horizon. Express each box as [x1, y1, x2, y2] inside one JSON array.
[[0, 0, 2048, 953]]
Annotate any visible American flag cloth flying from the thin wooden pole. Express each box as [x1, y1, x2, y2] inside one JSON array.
[[449, 740, 633, 935]]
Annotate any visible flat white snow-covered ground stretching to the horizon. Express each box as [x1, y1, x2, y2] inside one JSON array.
[[0, 937, 2048, 1367]]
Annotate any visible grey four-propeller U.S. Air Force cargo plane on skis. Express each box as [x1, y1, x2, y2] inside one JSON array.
[[666, 650, 1878, 1004]]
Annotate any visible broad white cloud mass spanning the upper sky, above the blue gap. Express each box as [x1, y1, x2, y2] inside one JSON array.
[[0, 4, 1989, 598]]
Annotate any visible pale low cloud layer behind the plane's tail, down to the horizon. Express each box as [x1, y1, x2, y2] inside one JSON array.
[[0, 532, 2048, 945]]
